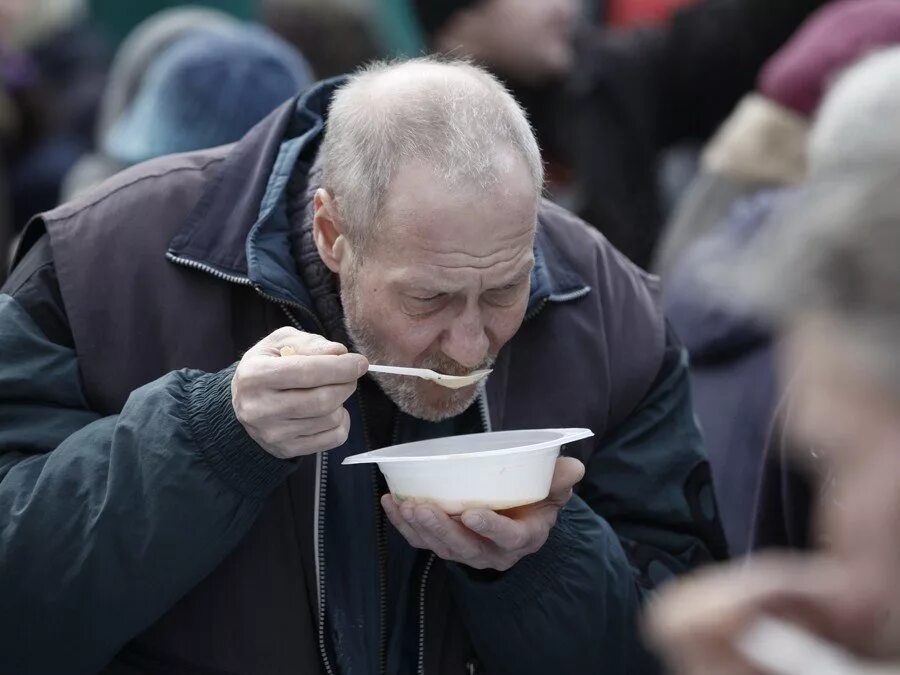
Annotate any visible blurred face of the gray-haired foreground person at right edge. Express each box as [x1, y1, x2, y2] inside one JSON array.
[[784, 318, 900, 656]]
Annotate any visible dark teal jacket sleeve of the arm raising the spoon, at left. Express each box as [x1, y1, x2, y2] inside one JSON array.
[[0, 241, 291, 674]]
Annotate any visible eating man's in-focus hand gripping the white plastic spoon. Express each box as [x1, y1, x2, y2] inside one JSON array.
[[231, 328, 369, 459]]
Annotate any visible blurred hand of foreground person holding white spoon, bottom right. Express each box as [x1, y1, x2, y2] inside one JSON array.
[[645, 554, 886, 675]]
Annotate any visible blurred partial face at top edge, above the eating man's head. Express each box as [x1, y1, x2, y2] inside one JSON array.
[[435, 0, 579, 84]]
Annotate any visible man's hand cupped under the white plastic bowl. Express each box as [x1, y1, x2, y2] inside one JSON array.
[[381, 457, 584, 571]]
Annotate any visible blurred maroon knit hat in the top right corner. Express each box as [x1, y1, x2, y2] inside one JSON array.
[[757, 0, 900, 117]]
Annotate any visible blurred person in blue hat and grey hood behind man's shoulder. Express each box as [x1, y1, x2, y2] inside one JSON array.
[[64, 10, 313, 199]]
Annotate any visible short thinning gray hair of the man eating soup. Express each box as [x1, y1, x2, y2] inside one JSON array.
[[320, 57, 544, 247]]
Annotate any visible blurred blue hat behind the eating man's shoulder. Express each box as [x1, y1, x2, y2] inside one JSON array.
[[103, 26, 313, 164]]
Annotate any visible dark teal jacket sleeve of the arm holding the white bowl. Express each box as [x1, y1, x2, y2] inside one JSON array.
[[450, 328, 726, 675]]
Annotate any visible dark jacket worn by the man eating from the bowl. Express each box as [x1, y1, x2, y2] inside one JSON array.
[[0, 76, 724, 675]]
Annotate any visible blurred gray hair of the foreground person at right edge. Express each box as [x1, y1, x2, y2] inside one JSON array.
[[742, 165, 900, 395]]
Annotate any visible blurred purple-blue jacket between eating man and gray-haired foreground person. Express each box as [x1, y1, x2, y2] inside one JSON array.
[[663, 190, 785, 555]]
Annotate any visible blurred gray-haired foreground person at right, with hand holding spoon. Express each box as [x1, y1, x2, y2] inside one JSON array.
[[648, 160, 900, 675]]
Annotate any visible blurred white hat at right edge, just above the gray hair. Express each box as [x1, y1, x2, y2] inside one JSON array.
[[809, 47, 900, 175]]
